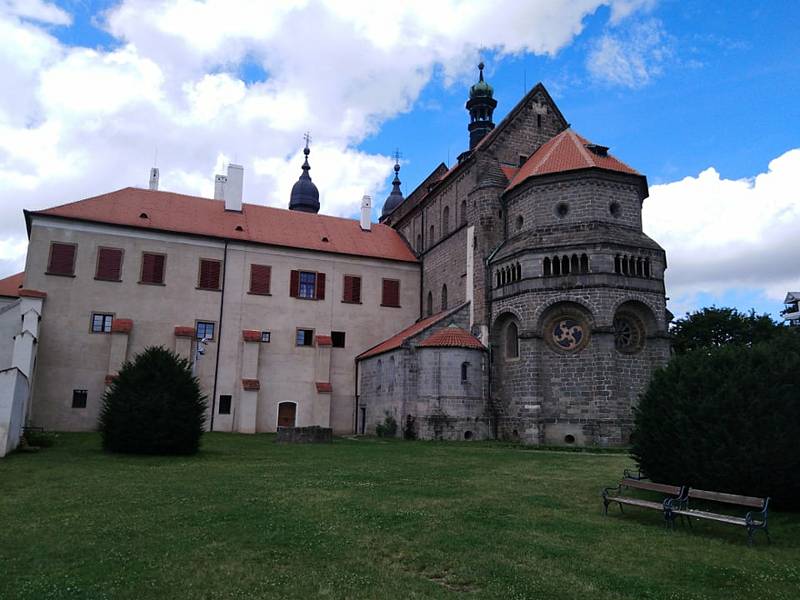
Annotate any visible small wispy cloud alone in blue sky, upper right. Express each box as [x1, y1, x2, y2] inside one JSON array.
[[586, 19, 672, 88]]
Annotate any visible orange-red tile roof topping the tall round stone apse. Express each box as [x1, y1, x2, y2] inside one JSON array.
[[506, 129, 639, 191]]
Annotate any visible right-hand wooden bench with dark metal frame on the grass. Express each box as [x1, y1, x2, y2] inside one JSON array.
[[664, 488, 771, 546]]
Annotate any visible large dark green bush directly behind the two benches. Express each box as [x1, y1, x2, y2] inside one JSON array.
[[632, 331, 800, 509]]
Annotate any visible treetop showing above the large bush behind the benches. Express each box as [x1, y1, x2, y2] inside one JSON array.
[[671, 306, 786, 354]]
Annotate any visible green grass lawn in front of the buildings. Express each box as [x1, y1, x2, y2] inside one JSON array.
[[0, 434, 800, 600]]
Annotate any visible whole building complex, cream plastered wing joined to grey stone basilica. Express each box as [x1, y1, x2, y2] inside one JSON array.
[[0, 65, 671, 456]]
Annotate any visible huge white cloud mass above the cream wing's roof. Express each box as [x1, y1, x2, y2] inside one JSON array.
[[0, 0, 649, 276]]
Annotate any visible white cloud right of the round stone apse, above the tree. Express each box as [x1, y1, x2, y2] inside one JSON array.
[[643, 148, 800, 307]]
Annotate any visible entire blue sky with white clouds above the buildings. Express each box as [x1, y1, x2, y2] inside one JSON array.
[[0, 0, 800, 317]]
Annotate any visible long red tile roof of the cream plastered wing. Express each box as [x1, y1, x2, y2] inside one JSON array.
[[30, 187, 417, 262]]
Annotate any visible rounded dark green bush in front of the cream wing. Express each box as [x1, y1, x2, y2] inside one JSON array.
[[100, 347, 206, 454]]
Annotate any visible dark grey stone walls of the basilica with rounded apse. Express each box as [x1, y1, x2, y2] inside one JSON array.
[[360, 76, 671, 445]]
